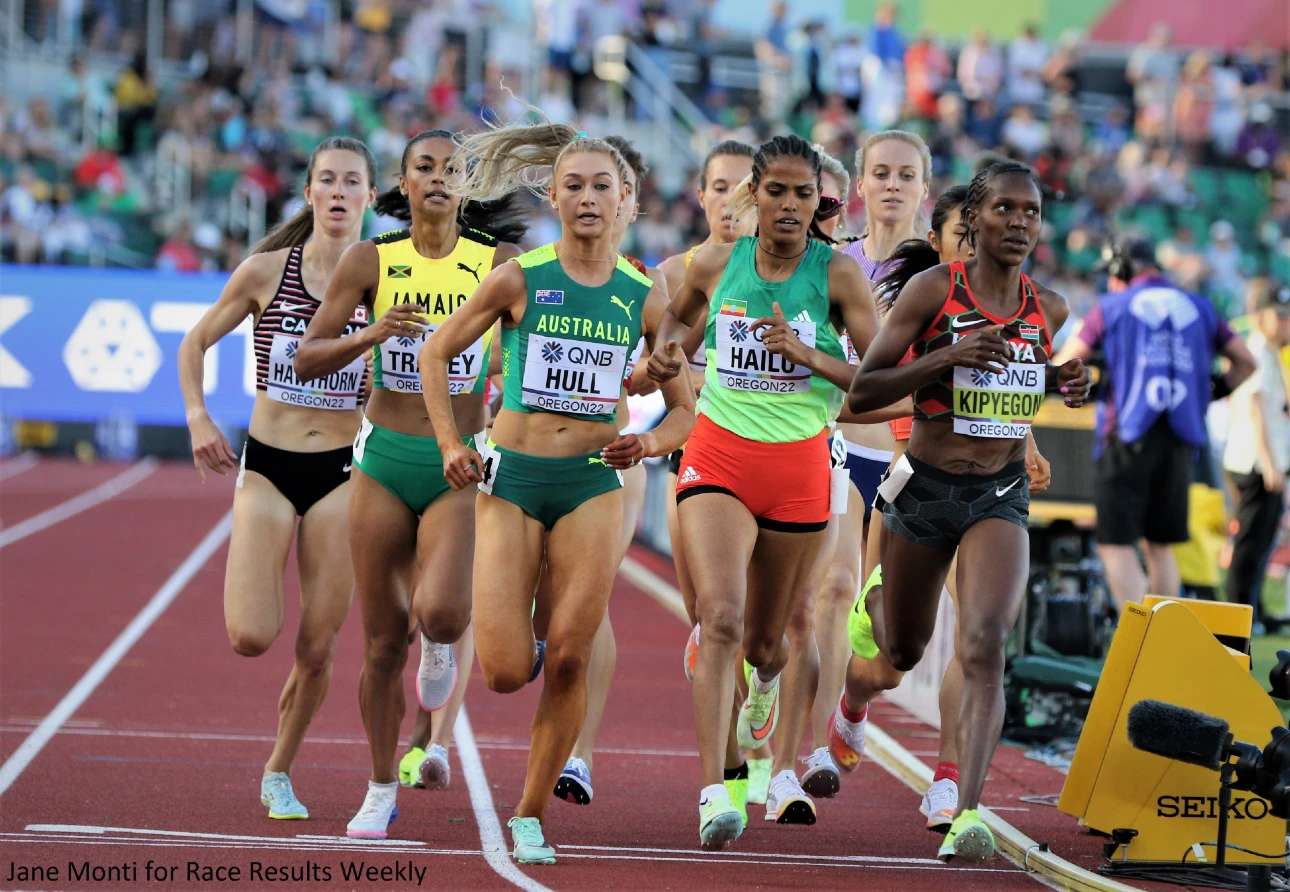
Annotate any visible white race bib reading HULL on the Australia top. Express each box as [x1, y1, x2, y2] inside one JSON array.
[[520, 334, 627, 414]]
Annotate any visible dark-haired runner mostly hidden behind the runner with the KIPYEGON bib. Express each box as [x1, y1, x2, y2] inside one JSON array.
[[828, 186, 1051, 833]]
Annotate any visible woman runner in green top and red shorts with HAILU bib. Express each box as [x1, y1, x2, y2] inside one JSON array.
[[649, 137, 877, 848]]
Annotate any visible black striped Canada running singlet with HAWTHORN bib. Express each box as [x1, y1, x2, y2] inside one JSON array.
[[254, 245, 368, 409]]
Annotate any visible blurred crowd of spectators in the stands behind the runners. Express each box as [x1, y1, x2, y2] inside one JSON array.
[[0, 0, 1290, 329]]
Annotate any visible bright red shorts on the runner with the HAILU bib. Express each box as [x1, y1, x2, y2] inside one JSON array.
[[676, 414, 829, 533]]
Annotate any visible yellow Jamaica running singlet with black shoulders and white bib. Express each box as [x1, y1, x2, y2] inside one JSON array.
[[372, 228, 497, 396]]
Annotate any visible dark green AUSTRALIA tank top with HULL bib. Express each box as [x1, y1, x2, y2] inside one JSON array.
[[502, 245, 653, 423]]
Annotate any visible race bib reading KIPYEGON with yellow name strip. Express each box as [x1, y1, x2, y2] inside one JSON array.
[[953, 363, 1045, 440]]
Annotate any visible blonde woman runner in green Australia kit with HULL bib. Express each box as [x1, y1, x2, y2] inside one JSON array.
[[422, 124, 694, 864]]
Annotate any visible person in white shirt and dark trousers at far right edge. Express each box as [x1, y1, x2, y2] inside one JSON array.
[[1223, 280, 1290, 632]]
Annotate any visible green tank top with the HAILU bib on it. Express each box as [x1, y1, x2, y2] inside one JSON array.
[[699, 236, 846, 443]]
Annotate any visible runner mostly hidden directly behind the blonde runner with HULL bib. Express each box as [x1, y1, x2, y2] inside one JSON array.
[[539, 137, 667, 806]]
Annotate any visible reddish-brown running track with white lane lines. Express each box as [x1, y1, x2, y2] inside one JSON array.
[[0, 457, 1176, 892]]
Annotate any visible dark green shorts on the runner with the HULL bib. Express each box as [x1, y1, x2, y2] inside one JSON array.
[[480, 438, 623, 529]]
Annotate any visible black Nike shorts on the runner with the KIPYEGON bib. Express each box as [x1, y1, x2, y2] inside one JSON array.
[[875, 453, 1031, 549]]
